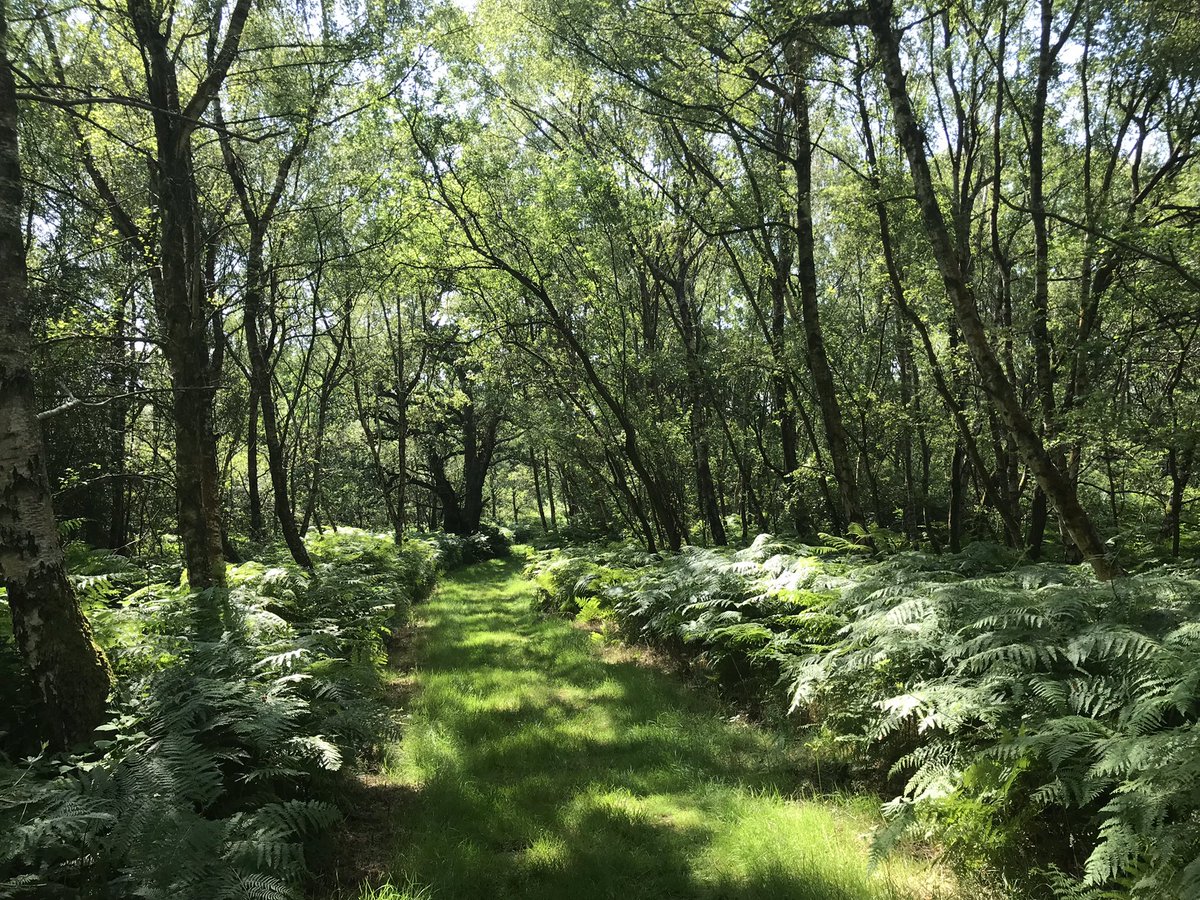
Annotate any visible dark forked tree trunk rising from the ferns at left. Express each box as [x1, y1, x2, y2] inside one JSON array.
[[44, 0, 252, 607]]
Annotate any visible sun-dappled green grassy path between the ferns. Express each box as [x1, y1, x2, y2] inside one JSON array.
[[365, 562, 952, 900]]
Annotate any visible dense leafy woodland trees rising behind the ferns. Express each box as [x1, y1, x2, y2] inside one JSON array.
[[0, 0, 1200, 884]]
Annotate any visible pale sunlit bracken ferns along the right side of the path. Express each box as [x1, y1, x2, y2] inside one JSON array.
[[530, 535, 1200, 900]]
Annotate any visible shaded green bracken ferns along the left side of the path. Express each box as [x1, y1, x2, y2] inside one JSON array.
[[0, 529, 434, 900]]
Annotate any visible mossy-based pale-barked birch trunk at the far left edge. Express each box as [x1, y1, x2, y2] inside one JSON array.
[[0, 15, 112, 749]]
